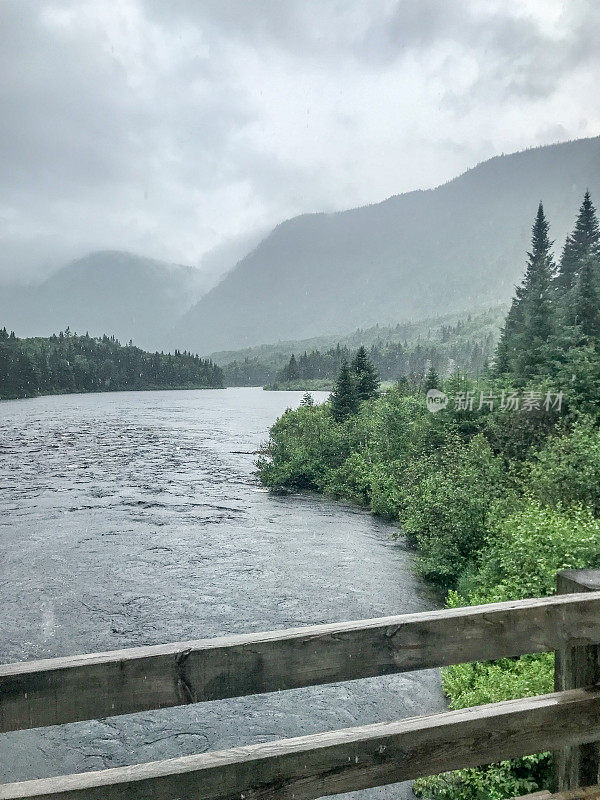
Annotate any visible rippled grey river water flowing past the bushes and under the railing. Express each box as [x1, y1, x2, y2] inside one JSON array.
[[0, 389, 444, 800]]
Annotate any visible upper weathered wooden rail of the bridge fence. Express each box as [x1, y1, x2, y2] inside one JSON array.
[[0, 591, 600, 732]]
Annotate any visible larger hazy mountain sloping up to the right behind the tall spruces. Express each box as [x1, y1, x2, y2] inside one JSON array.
[[172, 137, 600, 353]]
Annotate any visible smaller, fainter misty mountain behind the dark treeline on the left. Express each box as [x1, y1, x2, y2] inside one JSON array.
[[0, 250, 206, 349]]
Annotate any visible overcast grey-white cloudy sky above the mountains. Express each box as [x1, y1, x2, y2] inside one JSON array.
[[0, 0, 600, 279]]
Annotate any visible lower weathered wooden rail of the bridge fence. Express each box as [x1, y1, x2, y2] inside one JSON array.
[[0, 687, 600, 800]]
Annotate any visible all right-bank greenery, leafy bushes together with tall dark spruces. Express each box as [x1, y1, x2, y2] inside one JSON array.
[[259, 193, 600, 800]]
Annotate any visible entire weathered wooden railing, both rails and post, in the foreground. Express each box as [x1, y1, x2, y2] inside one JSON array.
[[0, 571, 600, 800]]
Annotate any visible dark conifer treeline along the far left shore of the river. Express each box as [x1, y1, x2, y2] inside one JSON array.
[[0, 328, 223, 399]]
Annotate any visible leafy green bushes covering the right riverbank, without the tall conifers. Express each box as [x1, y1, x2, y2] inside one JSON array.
[[259, 378, 600, 800]]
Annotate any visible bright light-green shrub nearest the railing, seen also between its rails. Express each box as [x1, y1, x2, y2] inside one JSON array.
[[416, 500, 600, 800]]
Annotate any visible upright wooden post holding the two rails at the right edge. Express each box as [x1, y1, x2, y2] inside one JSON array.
[[554, 569, 600, 792]]
